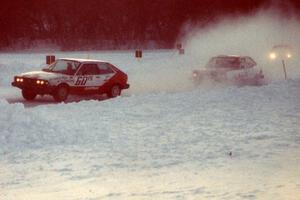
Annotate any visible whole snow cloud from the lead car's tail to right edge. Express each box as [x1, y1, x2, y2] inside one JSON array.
[[129, 5, 300, 94]]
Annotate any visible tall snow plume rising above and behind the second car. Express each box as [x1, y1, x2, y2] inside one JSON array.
[[181, 8, 300, 81]]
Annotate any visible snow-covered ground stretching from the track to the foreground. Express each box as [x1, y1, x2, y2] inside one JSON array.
[[0, 51, 300, 200]]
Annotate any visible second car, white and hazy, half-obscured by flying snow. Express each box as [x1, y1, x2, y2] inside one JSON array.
[[192, 55, 265, 86]]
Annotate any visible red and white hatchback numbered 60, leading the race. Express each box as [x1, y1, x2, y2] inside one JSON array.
[[12, 58, 129, 102]]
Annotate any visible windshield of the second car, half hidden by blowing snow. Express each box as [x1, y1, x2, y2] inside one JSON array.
[[206, 57, 240, 69]]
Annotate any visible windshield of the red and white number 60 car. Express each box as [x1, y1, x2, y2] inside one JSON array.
[[43, 60, 80, 75]]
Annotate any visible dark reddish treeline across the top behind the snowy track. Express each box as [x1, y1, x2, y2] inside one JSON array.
[[0, 0, 298, 50]]
